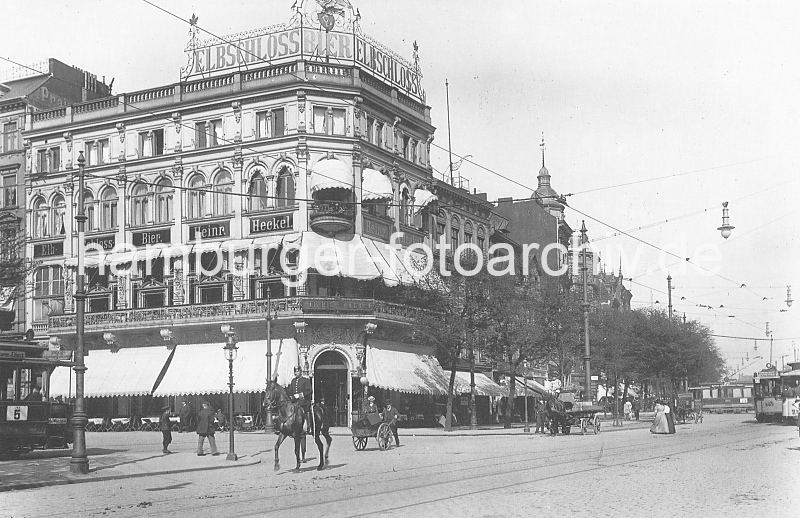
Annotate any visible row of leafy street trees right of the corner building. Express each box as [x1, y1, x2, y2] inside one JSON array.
[[398, 258, 723, 429]]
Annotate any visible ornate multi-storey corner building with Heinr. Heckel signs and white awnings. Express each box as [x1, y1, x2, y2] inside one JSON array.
[[24, 0, 504, 425]]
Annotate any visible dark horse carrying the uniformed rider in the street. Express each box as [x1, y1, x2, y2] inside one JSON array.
[[264, 381, 333, 471]]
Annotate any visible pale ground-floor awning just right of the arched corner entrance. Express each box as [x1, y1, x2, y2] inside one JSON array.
[[367, 341, 450, 396]]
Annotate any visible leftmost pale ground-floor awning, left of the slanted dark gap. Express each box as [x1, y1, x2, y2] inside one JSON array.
[[50, 346, 174, 397]]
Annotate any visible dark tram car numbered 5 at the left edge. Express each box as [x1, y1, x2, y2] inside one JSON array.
[[0, 337, 72, 454]]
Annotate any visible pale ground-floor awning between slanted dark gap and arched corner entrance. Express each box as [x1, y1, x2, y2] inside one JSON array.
[[153, 339, 297, 396]]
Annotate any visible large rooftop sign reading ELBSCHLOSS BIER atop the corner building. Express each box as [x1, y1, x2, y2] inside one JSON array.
[[181, 27, 425, 104]]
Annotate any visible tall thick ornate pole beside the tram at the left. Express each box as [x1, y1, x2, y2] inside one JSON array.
[[69, 151, 89, 475]]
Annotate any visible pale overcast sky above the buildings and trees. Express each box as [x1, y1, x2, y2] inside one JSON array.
[[0, 0, 800, 373]]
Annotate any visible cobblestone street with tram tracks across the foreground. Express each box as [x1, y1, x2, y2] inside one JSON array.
[[0, 414, 800, 517]]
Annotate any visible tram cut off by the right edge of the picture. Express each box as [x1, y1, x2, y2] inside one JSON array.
[[753, 362, 800, 423]]
